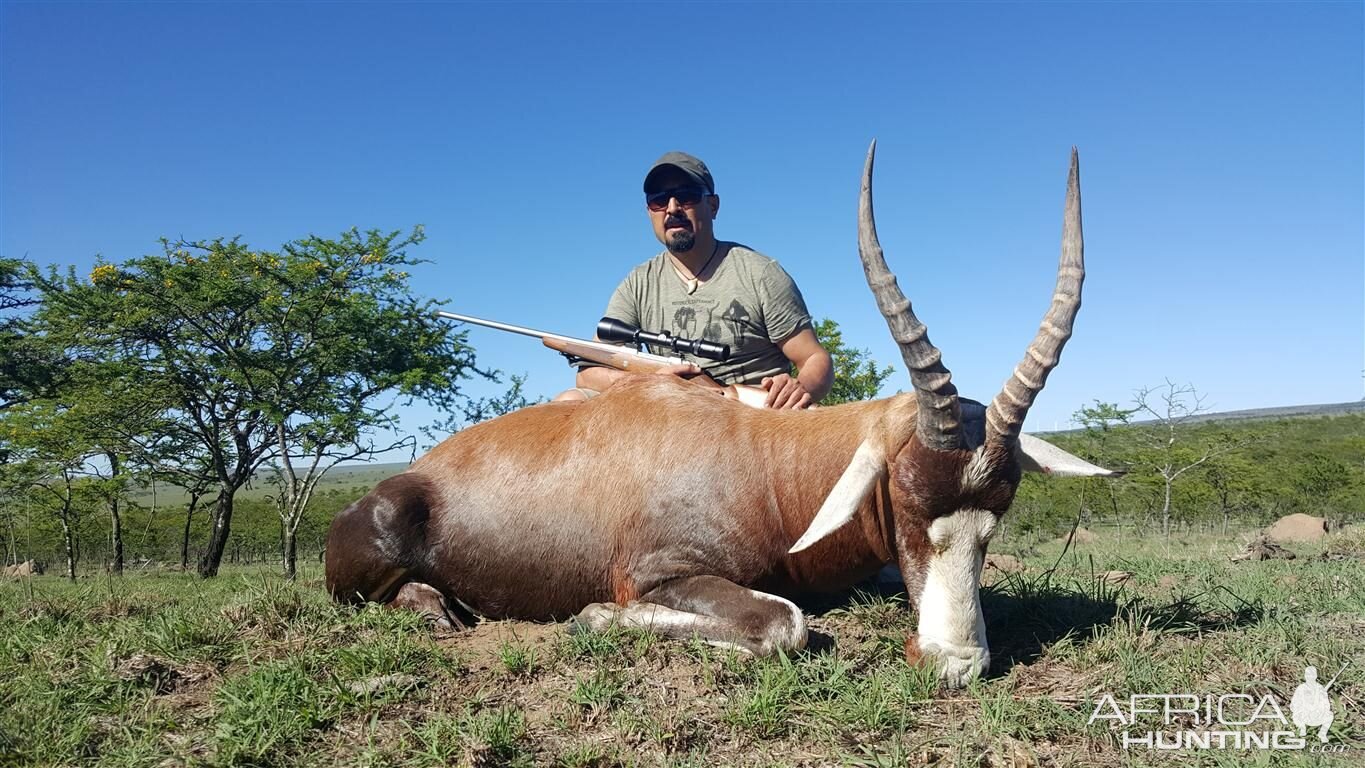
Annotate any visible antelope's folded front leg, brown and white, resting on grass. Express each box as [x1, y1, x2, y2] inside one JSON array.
[[576, 576, 805, 656]]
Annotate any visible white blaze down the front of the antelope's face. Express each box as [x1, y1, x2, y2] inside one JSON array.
[[919, 509, 995, 688]]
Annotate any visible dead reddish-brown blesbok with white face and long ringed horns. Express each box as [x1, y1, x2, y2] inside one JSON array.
[[326, 143, 1106, 686]]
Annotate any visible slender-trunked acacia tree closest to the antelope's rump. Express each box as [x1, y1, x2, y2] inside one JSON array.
[[257, 232, 491, 578]]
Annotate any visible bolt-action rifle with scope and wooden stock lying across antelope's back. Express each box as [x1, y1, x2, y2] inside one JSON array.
[[435, 312, 767, 408]]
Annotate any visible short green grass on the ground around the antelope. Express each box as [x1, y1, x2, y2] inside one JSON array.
[[0, 532, 1365, 768]]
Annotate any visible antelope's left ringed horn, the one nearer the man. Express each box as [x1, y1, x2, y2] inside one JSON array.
[[857, 141, 964, 450]]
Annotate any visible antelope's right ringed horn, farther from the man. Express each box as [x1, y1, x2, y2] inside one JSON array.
[[986, 147, 1085, 443]]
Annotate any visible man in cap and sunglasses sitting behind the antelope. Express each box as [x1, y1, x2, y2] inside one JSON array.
[[556, 151, 834, 408]]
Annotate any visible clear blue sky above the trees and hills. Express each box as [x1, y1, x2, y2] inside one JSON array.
[[0, 0, 1365, 441]]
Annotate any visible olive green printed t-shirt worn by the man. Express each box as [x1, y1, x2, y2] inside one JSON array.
[[606, 241, 811, 385]]
